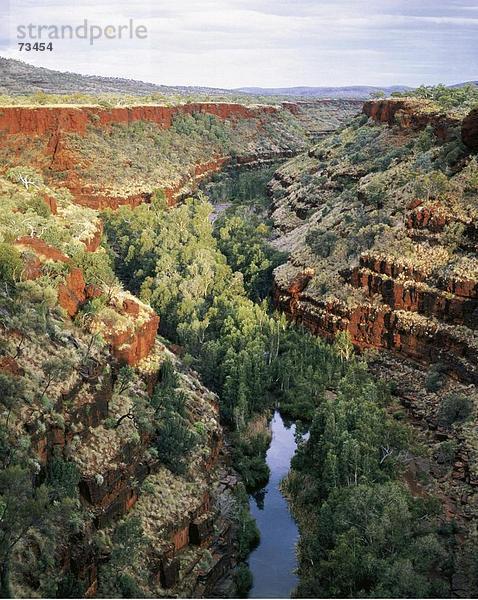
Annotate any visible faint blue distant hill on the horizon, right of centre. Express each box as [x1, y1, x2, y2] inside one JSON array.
[[235, 85, 413, 98]]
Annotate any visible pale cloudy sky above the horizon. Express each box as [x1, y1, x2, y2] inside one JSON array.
[[0, 0, 478, 88]]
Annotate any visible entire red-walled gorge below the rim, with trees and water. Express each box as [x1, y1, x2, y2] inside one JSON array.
[[0, 81, 478, 598]]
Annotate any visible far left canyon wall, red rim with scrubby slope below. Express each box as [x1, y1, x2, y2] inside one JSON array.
[[0, 102, 357, 210]]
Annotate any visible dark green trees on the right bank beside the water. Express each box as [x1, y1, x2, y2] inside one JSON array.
[[285, 359, 452, 598]]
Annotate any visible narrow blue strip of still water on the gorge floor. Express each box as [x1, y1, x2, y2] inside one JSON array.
[[249, 411, 299, 598]]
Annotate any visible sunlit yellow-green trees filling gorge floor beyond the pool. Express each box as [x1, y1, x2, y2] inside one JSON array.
[[106, 188, 354, 429]]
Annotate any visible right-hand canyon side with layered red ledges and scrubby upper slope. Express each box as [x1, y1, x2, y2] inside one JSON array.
[[270, 99, 478, 383]]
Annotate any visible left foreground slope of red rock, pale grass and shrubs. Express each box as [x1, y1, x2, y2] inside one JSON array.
[[0, 172, 237, 597]]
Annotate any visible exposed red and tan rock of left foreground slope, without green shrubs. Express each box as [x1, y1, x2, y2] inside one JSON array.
[[7, 200, 238, 597]]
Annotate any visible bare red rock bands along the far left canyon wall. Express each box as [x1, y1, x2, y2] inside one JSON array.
[[0, 102, 284, 210]]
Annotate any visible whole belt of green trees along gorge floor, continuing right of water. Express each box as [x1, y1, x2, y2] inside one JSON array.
[[102, 185, 458, 597]]
